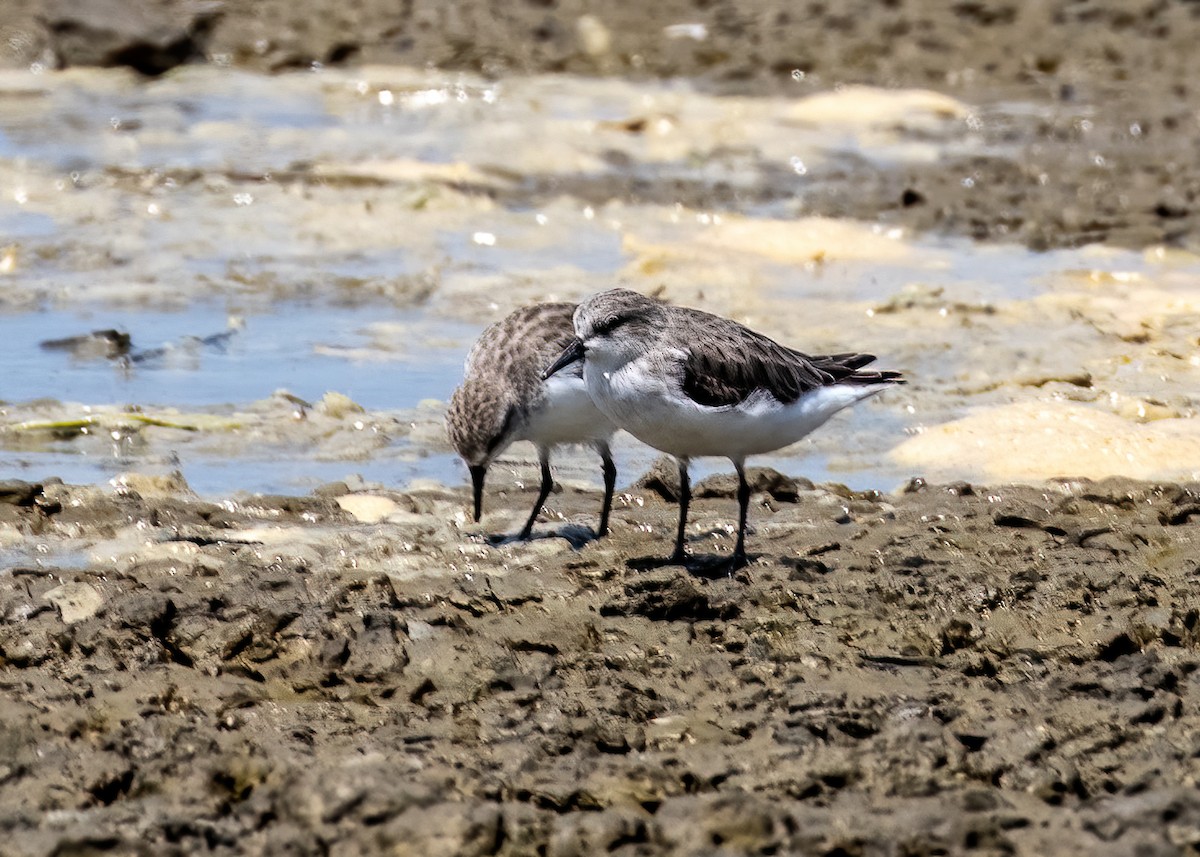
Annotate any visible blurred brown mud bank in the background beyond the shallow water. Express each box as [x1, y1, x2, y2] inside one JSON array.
[[9, 0, 1200, 250]]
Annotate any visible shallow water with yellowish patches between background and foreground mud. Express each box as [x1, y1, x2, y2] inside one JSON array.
[[0, 68, 1200, 497]]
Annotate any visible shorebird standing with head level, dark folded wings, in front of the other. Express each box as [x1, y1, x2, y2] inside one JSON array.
[[542, 289, 904, 565]]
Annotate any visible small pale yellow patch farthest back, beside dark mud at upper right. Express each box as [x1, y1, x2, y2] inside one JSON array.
[[784, 86, 971, 127]]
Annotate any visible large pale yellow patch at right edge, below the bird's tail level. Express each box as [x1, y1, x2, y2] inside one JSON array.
[[892, 402, 1200, 481]]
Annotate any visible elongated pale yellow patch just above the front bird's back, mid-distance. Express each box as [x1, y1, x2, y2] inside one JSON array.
[[624, 217, 916, 266]]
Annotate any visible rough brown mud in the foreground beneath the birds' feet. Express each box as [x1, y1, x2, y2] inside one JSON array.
[[0, 472, 1200, 856]]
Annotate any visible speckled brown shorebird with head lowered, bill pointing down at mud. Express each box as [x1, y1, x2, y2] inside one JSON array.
[[446, 304, 617, 539]]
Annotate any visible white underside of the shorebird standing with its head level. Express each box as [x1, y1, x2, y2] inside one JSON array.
[[584, 360, 886, 459]]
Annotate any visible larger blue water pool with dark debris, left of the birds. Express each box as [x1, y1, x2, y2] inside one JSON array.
[[0, 301, 465, 410]]
